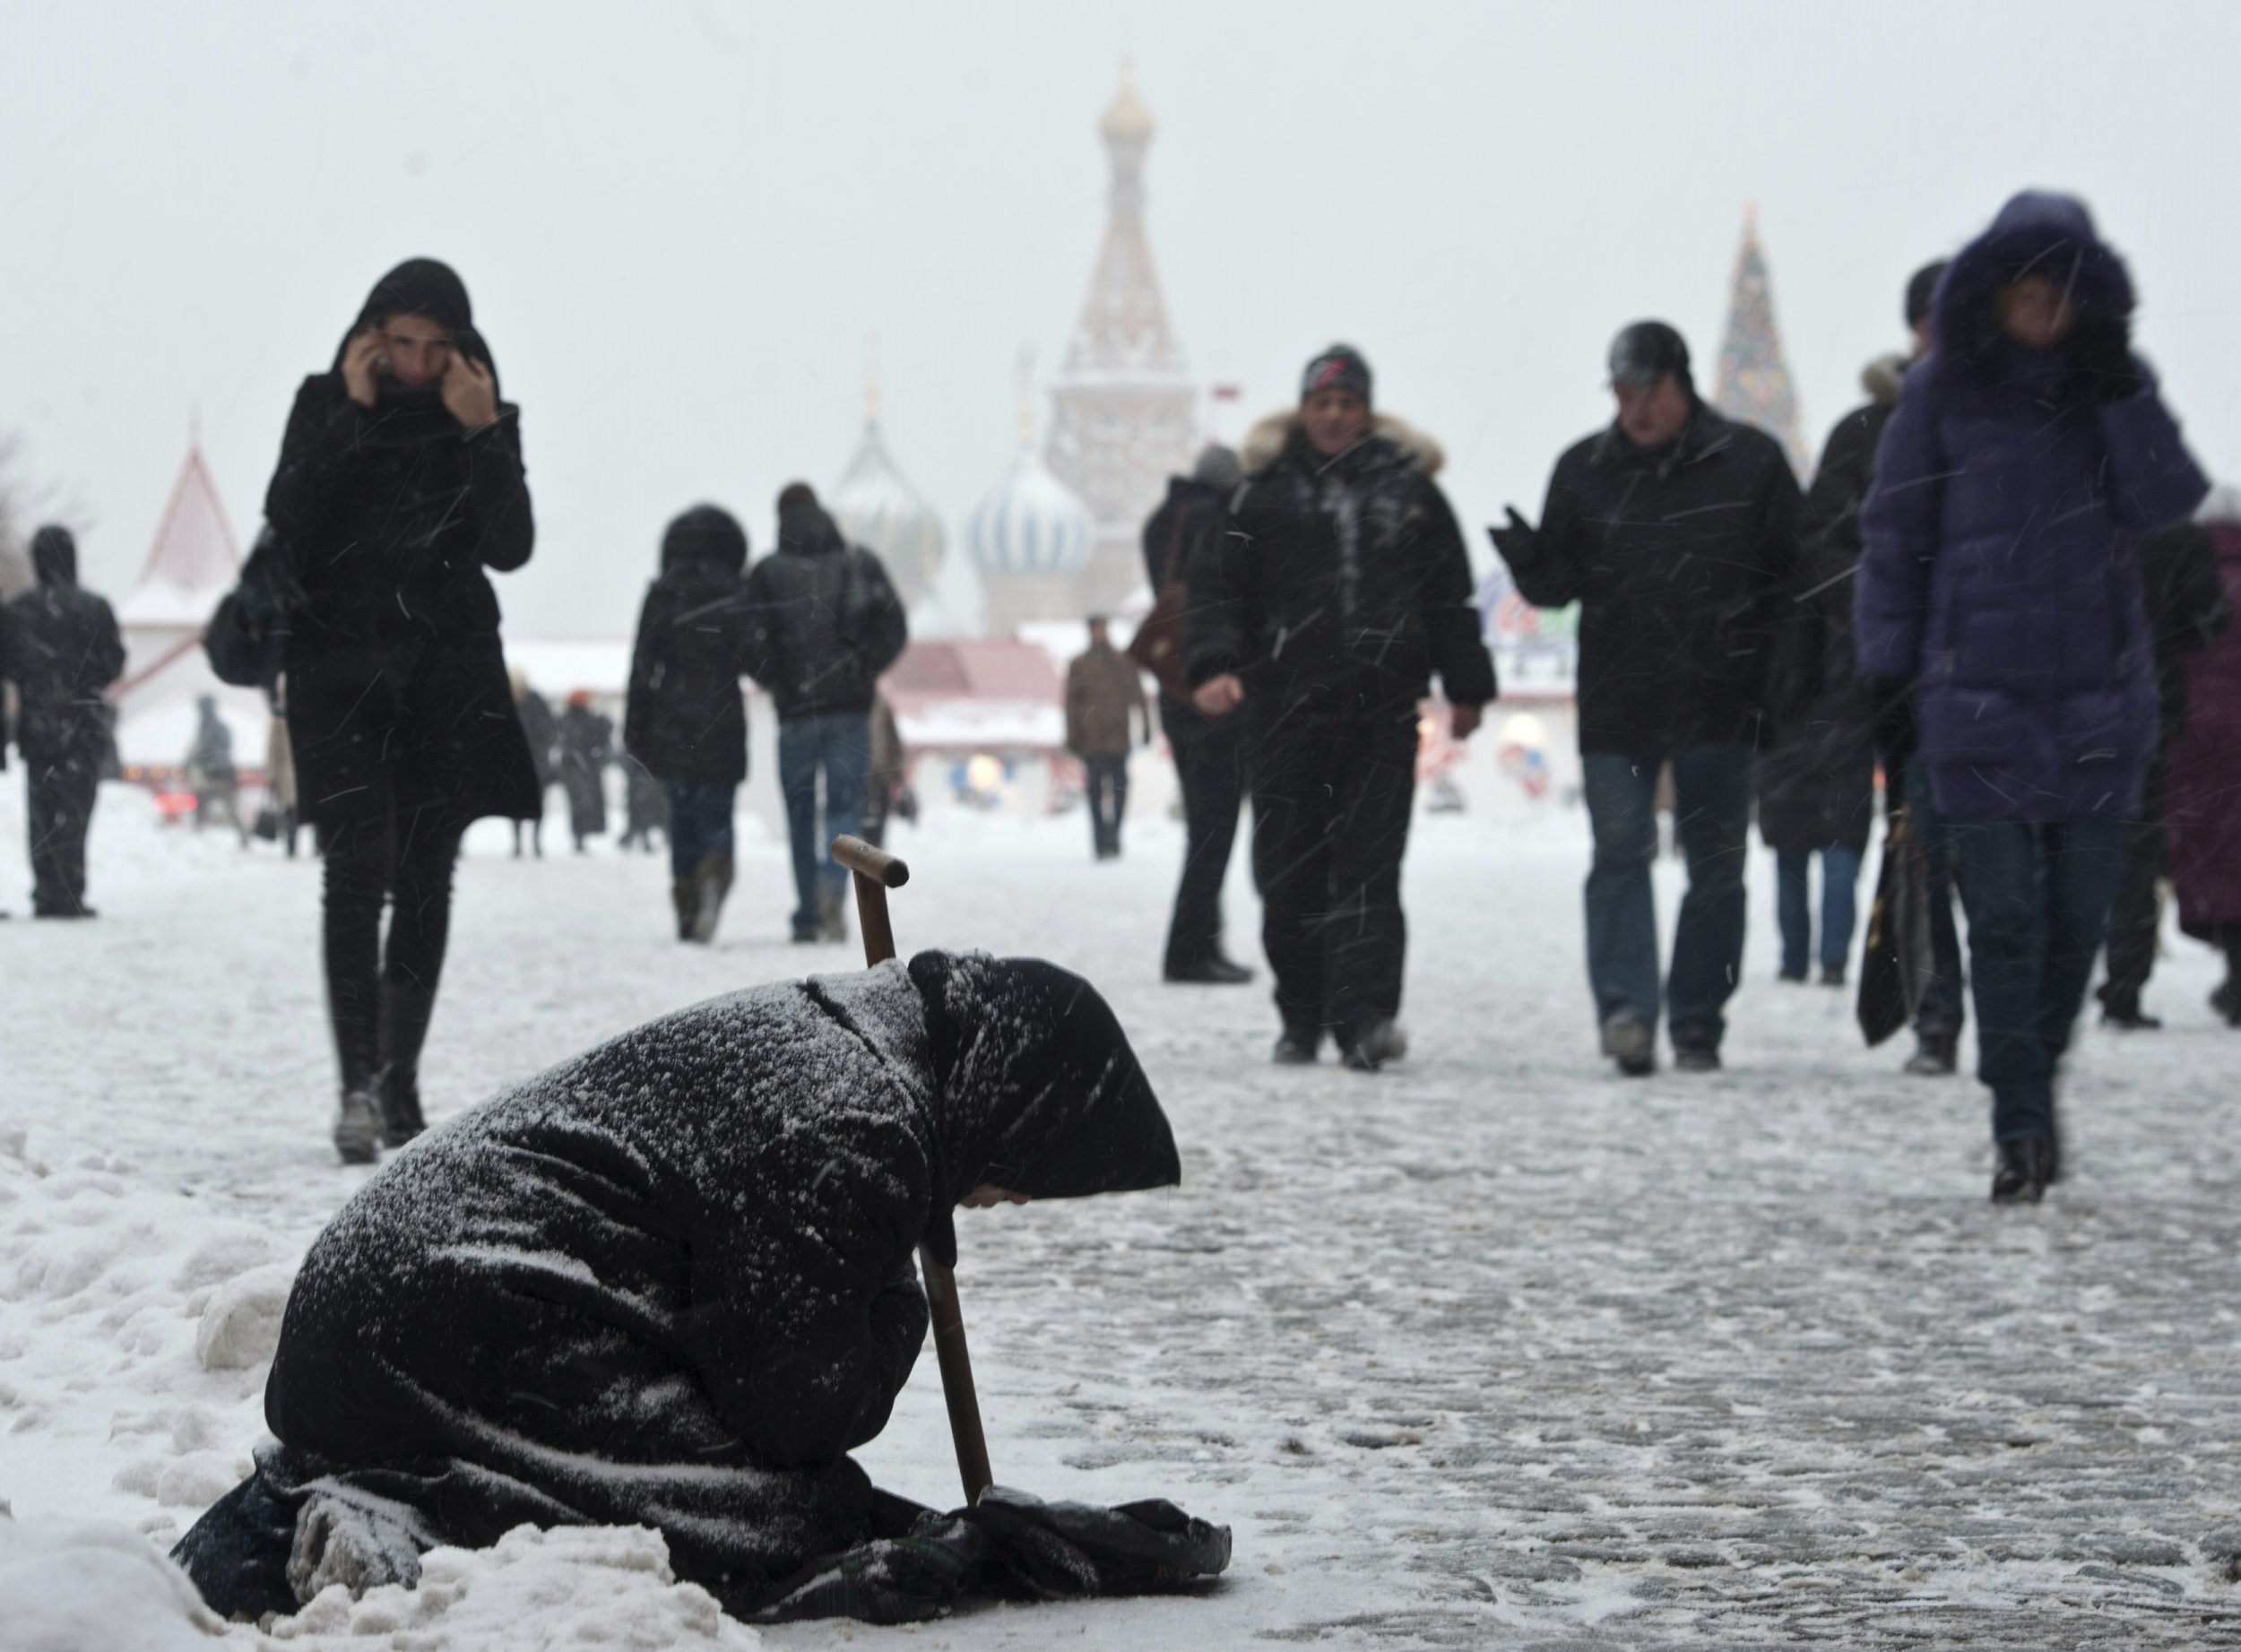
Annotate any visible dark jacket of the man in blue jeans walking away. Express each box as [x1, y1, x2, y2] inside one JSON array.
[[747, 505, 910, 722]]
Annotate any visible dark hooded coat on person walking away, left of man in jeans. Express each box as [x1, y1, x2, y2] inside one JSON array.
[[623, 505, 760, 787]]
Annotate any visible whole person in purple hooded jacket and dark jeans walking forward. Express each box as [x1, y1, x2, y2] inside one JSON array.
[[1858, 191, 2210, 1204]]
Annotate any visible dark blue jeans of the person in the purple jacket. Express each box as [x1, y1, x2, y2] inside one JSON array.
[[1945, 820, 2124, 1141]]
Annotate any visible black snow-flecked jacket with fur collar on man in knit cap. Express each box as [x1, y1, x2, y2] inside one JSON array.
[[1183, 412, 1495, 715]]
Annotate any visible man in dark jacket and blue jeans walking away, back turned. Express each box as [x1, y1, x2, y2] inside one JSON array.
[[747, 482, 910, 941]]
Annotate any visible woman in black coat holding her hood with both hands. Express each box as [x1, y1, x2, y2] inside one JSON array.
[[264, 258, 542, 1163]]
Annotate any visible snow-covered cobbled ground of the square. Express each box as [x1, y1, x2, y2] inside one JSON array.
[[0, 774, 2241, 1648]]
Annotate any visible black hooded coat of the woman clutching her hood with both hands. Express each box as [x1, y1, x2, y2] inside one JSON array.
[[264, 258, 538, 829]]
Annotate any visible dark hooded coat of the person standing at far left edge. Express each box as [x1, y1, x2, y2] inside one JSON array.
[[0, 527, 125, 771]]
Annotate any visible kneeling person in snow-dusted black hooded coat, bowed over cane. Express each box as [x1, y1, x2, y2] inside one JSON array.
[[175, 953, 1181, 1612]]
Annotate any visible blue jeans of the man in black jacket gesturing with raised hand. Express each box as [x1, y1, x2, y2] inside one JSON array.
[[1580, 747, 1751, 1049]]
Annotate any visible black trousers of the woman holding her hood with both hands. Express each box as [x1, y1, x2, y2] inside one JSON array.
[[325, 816, 460, 1092]]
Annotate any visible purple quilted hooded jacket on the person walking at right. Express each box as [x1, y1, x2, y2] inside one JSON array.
[[1858, 191, 2210, 820]]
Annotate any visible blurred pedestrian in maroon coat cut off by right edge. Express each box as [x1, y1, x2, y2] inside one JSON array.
[[2169, 487, 2241, 1026]]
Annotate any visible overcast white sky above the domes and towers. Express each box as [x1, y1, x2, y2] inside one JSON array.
[[0, 0, 2241, 635]]
